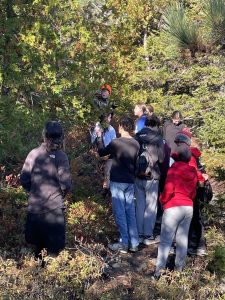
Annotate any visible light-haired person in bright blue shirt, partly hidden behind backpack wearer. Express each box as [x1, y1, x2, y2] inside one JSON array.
[[134, 103, 154, 133]]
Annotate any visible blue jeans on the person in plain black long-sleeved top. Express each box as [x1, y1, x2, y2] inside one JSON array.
[[110, 181, 139, 247]]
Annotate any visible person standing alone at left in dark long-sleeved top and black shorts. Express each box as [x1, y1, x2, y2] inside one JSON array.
[[20, 121, 71, 257]]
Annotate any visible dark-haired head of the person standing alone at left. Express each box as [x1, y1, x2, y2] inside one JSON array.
[[43, 121, 64, 150]]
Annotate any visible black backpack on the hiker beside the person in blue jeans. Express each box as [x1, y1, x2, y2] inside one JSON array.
[[136, 144, 152, 176]]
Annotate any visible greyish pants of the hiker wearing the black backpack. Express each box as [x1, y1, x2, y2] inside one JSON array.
[[134, 178, 159, 236]]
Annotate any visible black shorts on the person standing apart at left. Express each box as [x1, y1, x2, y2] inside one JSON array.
[[25, 208, 65, 254]]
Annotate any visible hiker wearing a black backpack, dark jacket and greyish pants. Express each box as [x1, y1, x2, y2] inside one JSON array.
[[135, 115, 165, 245]]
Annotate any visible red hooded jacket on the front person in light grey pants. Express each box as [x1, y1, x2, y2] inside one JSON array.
[[160, 161, 198, 209]]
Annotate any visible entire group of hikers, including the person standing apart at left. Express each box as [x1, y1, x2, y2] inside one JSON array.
[[20, 84, 212, 277]]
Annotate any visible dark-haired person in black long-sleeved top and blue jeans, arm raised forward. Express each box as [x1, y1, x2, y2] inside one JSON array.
[[97, 117, 139, 253]]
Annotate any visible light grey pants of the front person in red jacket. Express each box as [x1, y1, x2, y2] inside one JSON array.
[[156, 206, 193, 275]]
